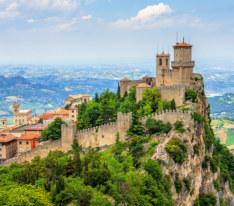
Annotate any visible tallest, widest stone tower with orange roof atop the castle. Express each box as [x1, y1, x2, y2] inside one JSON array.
[[171, 40, 195, 85]]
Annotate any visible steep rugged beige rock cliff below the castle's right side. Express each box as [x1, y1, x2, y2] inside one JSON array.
[[152, 76, 234, 206]]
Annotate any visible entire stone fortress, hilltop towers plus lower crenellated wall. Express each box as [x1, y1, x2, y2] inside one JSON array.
[[2, 40, 202, 163]]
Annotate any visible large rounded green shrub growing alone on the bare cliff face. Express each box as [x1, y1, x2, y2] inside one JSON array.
[[165, 138, 187, 164]]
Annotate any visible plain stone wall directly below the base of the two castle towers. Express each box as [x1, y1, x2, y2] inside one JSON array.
[[159, 85, 186, 106]]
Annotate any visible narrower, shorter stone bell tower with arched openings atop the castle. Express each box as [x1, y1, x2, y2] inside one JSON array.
[[156, 52, 170, 87]]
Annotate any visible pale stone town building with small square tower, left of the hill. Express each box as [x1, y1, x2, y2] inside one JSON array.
[[13, 103, 32, 126]]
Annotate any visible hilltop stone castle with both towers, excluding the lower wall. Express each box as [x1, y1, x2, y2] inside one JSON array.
[[120, 40, 195, 106]]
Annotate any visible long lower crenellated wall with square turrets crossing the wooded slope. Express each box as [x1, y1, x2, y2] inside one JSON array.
[[4, 111, 193, 165]]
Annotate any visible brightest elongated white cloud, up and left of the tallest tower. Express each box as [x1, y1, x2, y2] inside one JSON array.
[[113, 3, 172, 28]]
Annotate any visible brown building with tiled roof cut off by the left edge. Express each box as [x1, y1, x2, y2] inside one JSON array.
[[0, 134, 17, 163]]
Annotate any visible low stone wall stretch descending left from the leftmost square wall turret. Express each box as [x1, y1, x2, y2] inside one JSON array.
[[3, 140, 62, 165]]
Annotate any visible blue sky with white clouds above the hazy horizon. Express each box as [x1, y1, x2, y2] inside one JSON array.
[[0, 0, 234, 64]]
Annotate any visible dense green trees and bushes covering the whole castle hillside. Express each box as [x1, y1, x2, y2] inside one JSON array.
[[0, 88, 234, 206]]
